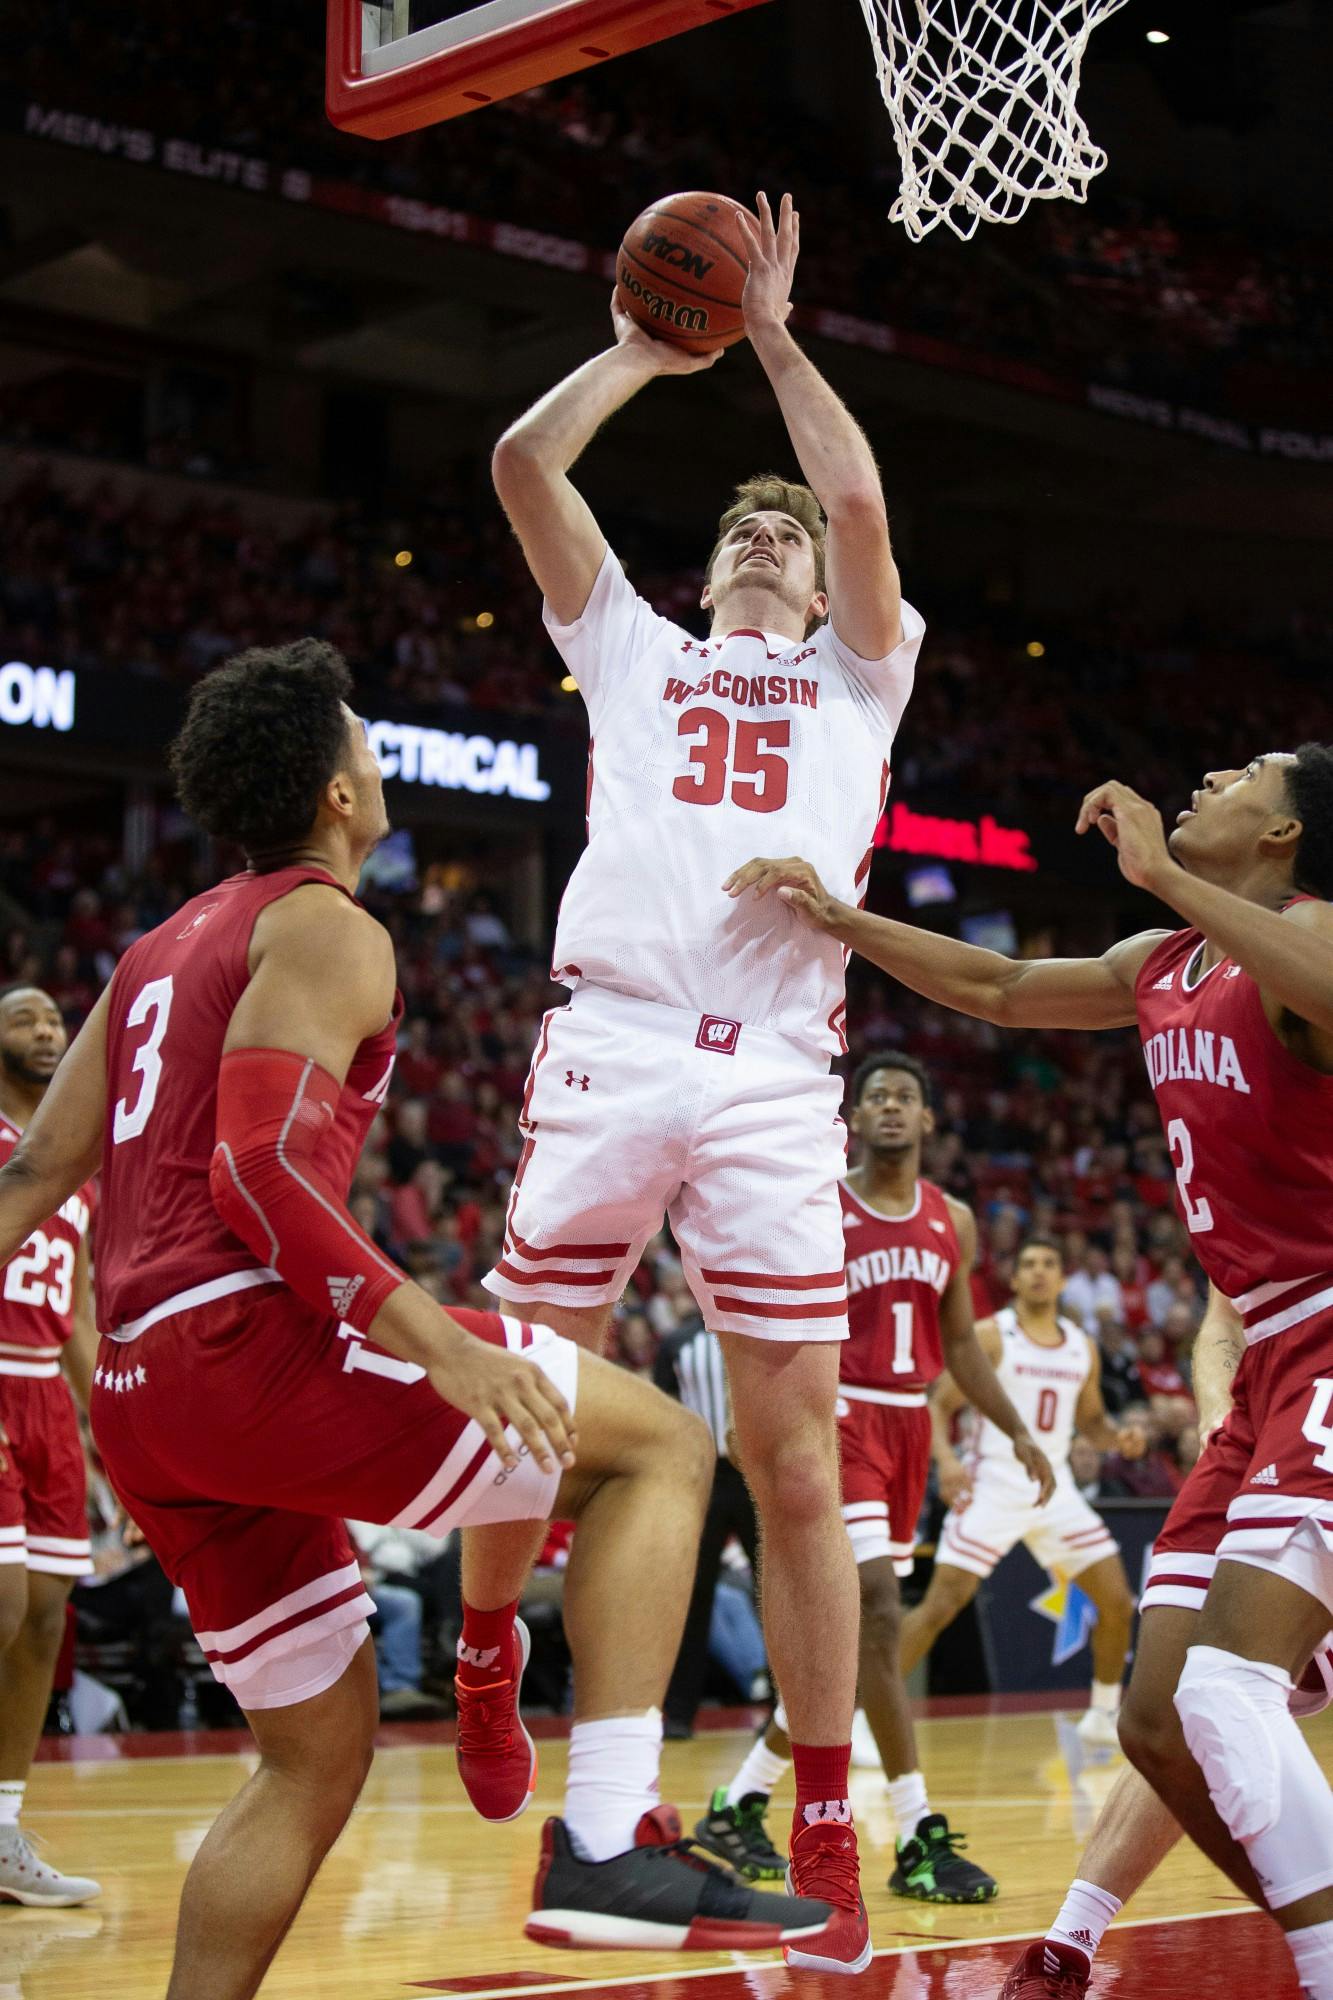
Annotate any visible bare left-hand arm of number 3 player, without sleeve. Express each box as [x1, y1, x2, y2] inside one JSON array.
[[0, 992, 108, 1264]]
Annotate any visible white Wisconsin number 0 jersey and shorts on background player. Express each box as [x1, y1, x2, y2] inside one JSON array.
[[939, 1306, 1117, 1576]]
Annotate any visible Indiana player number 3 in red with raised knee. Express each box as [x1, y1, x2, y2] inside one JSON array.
[[0, 640, 833, 2000]]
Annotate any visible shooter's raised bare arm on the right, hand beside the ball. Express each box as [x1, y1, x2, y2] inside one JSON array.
[[737, 194, 903, 660]]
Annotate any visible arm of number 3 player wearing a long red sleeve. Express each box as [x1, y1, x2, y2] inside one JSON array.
[[211, 884, 574, 1472]]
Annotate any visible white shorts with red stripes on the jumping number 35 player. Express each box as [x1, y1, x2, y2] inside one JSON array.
[[482, 986, 847, 1340]]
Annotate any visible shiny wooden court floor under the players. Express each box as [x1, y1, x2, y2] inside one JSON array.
[[10, 1712, 1333, 2000]]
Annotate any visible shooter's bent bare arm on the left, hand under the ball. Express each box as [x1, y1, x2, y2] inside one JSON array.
[[490, 298, 723, 624]]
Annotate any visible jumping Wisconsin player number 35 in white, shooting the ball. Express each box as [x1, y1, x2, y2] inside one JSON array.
[[480, 196, 923, 1972]]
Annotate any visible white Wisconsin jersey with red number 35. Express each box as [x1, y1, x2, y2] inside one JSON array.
[[544, 550, 925, 1052]]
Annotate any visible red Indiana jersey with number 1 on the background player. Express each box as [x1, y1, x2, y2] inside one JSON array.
[[839, 1180, 961, 1394]]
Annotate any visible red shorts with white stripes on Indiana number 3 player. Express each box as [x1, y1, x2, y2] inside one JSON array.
[[92, 1280, 578, 1708]]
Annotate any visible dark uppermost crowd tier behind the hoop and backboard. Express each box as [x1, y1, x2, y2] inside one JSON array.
[[10, 0, 1333, 422]]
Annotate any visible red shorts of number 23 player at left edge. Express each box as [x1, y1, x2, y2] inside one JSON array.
[[0, 1374, 92, 1578]]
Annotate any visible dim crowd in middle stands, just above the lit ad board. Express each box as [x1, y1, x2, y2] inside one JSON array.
[[0, 460, 1333, 866]]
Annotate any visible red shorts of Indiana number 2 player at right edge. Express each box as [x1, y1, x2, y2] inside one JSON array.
[[1143, 1312, 1333, 1612]]
